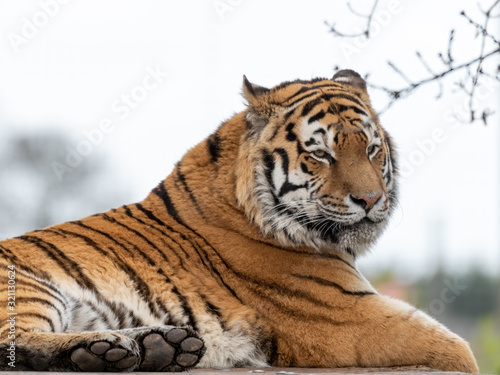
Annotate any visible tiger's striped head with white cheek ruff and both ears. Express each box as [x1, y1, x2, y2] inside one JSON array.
[[236, 70, 396, 254]]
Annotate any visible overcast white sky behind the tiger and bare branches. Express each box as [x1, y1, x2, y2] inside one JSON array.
[[0, 0, 500, 275]]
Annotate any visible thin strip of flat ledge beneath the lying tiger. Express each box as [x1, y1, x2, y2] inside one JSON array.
[[1, 366, 474, 375]]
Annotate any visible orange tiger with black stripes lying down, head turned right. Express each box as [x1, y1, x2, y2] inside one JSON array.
[[0, 69, 478, 373]]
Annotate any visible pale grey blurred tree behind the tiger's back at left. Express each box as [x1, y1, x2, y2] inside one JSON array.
[[0, 132, 131, 240]]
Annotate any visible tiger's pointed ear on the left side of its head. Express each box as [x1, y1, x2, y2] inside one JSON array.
[[243, 76, 270, 136]]
